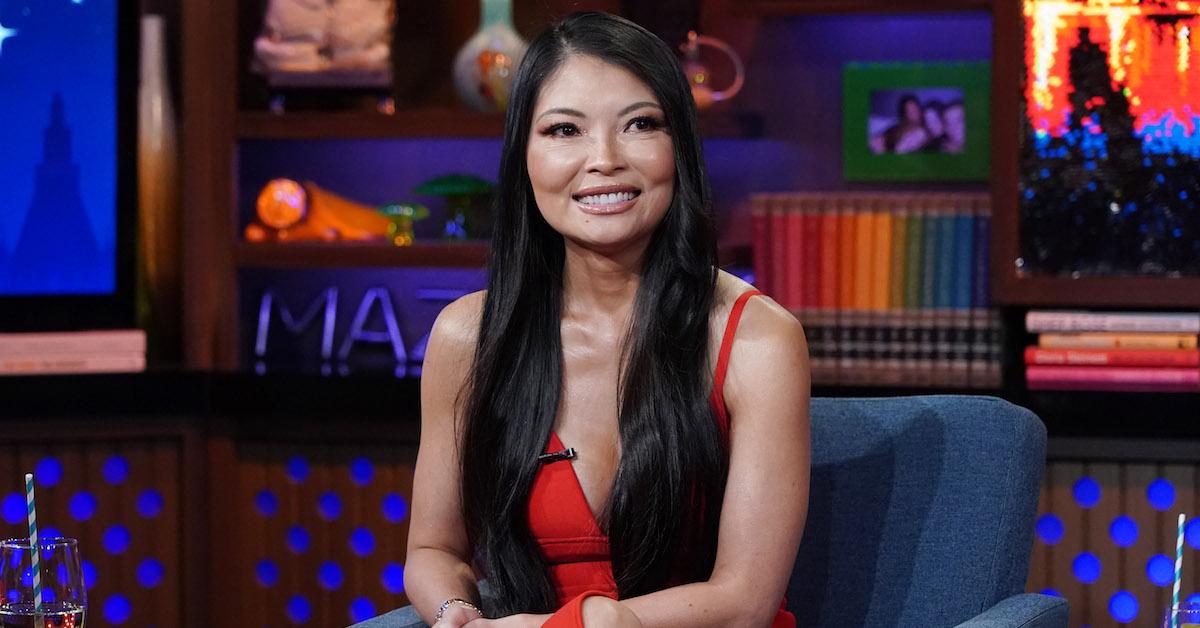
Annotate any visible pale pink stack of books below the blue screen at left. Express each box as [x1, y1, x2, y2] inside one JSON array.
[[0, 329, 146, 375]]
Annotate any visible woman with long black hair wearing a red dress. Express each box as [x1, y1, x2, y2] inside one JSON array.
[[406, 13, 809, 628]]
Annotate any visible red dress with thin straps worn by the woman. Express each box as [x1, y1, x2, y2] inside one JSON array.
[[528, 291, 796, 628]]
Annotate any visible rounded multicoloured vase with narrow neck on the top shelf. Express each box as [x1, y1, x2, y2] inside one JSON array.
[[454, 0, 528, 112]]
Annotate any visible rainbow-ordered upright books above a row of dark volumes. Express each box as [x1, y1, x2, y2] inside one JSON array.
[[751, 192, 1002, 388]]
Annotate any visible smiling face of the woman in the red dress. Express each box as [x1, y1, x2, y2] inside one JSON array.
[[526, 54, 676, 258]]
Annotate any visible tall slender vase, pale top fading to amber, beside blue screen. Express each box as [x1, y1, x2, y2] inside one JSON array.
[[137, 16, 180, 363]]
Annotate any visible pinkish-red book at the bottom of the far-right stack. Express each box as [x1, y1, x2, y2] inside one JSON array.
[[1025, 366, 1200, 391]]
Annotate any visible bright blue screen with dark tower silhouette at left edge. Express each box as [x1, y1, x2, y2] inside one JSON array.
[[0, 0, 117, 297]]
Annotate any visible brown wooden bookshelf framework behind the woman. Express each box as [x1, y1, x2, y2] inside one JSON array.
[[180, 0, 1200, 377]]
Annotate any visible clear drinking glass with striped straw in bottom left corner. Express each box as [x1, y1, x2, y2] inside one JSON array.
[[0, 537, 88, 628]]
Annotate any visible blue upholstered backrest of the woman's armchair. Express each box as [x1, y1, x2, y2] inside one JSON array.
[[787, 395, 1045, 628]]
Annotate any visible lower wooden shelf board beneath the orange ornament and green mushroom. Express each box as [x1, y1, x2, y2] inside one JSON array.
[[238, 240, 750, 269]]
